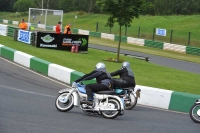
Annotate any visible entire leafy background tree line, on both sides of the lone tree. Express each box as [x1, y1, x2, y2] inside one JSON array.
[[0, 0, 200, 15]]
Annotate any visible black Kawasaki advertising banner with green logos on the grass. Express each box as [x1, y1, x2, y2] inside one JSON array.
[[36, 32, 89, 52]]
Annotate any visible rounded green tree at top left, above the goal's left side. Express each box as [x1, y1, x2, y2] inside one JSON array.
[[13, 0, 36, 12]]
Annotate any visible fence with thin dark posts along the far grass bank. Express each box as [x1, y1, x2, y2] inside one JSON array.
[[76, 23, 200, 47]]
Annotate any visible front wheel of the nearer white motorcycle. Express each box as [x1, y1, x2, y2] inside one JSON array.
[[55, 92, 74, 112]]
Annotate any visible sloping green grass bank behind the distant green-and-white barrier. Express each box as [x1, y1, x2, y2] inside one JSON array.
[[0, 12, 200, 47]]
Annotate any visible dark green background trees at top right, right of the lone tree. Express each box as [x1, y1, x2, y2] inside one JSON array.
[[142, 0, 200, 15]]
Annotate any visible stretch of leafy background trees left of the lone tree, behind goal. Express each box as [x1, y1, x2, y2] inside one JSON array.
[[0, 0, 99, 13]]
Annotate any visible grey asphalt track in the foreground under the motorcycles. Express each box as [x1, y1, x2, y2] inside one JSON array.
[[0, 57, 200, 133]]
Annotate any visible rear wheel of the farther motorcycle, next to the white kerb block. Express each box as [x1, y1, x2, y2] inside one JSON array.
[[124, 93, 138, 110]]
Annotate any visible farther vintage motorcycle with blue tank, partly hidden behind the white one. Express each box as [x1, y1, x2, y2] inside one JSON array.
[[115, 87, 141, 110]]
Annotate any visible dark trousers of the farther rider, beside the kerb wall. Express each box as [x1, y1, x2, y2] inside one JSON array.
[[113, 78, 135, 88]]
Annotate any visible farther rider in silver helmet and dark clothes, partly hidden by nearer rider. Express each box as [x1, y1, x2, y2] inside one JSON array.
[[110, 61, 135, 88]]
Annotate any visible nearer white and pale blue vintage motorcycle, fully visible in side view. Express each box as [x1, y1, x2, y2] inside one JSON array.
[[55, 82, 124, 119]]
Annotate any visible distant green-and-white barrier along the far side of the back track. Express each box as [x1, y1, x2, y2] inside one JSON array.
[[0, 21, 200, 56]]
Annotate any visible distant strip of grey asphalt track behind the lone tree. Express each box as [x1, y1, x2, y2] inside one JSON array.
[[89, 44, 200, 74]]
